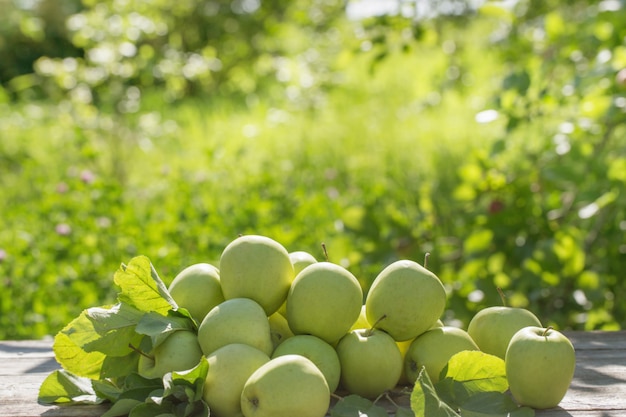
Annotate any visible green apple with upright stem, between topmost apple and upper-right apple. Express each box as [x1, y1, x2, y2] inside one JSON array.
[[287, 262, 363, 344]]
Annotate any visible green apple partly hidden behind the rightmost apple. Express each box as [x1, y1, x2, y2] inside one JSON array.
[[467, 306, 541, 359]]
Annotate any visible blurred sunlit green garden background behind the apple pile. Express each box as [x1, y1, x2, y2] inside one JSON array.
[[0, 0, 626, 338]]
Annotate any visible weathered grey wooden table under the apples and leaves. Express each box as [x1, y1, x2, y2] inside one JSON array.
[[0, 331, 626, 417]]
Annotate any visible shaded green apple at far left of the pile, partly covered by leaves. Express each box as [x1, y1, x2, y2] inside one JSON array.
[[137, 330, 202, 379]]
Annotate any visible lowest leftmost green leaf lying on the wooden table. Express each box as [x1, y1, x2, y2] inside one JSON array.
[[38, 369, 104, 404]]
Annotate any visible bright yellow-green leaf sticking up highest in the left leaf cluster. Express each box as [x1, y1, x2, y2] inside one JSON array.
[[113, 256, 178, 315]]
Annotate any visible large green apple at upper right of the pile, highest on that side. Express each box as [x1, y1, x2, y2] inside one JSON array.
[[365, 260, 446, 342]]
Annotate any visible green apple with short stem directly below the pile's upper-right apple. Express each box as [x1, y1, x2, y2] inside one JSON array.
[[335, 329, 402, 399]]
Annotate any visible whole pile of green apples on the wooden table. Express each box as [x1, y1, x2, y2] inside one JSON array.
[[144, 235, 575, 417]]
